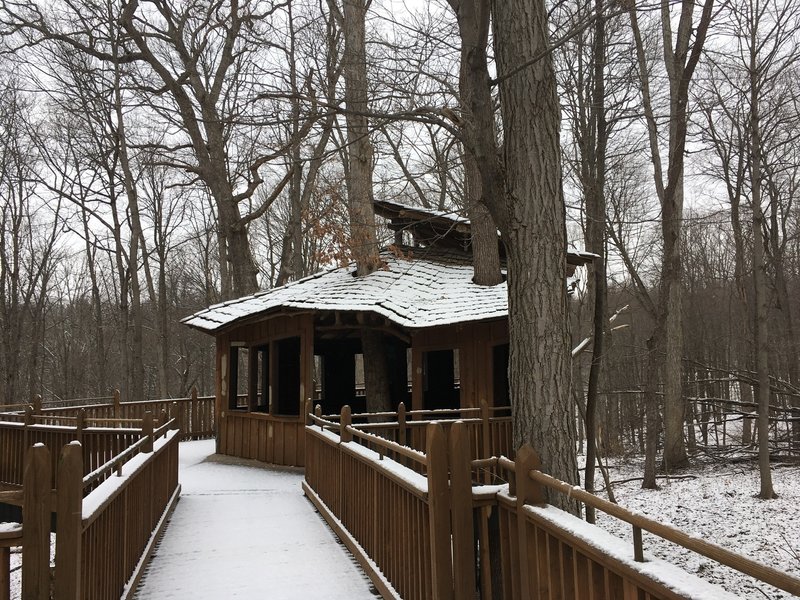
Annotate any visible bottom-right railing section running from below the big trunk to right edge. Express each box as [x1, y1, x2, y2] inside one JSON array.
[[497, 446, 800, 598]]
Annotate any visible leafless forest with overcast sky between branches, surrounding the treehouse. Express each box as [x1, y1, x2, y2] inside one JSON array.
[[0, 0, 800, 506]]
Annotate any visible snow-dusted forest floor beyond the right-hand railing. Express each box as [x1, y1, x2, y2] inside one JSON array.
[[597, 457, 800, 600]]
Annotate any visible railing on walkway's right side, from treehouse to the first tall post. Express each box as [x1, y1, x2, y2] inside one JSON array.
[[303, 413, 449, 600]]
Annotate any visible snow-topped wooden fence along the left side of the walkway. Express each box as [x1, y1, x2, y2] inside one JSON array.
[[0, 414, 180, 600]]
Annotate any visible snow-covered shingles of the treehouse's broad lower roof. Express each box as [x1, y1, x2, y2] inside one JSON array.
[[181, 248, 508, 333]]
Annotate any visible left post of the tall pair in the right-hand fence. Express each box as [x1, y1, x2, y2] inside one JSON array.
[[426, 423, 453, 600]]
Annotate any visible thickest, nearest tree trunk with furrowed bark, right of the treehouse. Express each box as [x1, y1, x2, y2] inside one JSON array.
[[493, 0, 578, 512]]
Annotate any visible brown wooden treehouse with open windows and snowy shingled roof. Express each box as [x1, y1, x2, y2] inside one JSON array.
[[183, 202, 592, 466]]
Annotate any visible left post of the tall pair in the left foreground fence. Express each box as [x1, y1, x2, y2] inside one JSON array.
[[22, 444, 52, 600]]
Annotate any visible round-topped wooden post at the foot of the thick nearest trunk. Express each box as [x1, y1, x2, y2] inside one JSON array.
[[514, 444, 548, 598]]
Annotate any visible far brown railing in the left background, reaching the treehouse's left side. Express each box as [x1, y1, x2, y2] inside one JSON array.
[[0, 389, 215, 441]]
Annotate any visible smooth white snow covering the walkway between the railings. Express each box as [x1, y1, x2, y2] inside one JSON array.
[[135, 440, 379, 600]]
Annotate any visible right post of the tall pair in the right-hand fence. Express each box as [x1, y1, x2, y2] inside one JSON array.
[[448, 421, 475, 600]]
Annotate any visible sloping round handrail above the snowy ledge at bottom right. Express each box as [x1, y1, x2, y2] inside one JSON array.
[[524, 472, 800, 595]]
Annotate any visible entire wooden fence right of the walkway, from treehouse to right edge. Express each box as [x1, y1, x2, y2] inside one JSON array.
[[303, 407, 800, 600]]
